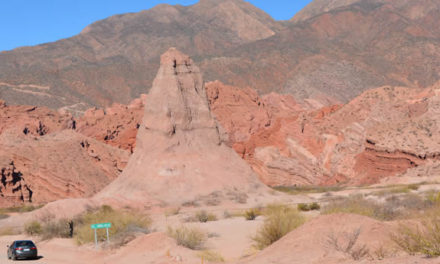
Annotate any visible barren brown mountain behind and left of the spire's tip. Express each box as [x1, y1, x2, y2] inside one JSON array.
[[0, 0, 282, 110]]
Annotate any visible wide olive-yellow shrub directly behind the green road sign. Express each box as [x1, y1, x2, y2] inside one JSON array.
[[74, 205, 151, 244]]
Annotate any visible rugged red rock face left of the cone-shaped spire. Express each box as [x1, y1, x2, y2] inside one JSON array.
[[0, 103, 132, 207]]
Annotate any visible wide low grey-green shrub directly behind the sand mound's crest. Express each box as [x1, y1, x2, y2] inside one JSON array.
[[321, 195, 399, 220]]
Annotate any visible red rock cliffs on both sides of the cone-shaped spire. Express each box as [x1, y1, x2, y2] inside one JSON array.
[[0, 79, 440, 206]]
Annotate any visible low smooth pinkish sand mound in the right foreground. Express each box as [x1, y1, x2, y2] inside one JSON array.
[[240, 214, 425, 264]]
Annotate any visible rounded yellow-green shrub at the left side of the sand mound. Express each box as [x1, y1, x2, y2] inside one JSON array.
[[252, 204, 305, 249]]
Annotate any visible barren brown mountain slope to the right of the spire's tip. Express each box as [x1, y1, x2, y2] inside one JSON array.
[[202, 0, 440, 102]]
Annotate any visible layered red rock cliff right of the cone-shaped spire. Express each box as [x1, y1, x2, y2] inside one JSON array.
[[207, 82, 440, 186]]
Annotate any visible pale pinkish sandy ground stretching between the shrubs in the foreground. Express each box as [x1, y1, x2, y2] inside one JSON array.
[[0, 184, 440, 264]]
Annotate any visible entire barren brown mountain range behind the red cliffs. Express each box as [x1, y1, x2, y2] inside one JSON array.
[[0, 0, 440, 112]]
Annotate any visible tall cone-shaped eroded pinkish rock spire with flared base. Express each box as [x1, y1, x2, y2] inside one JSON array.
[[97, 48, 263, 204]]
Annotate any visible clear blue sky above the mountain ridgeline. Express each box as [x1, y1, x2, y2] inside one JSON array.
[[0, 0, 311, 51]]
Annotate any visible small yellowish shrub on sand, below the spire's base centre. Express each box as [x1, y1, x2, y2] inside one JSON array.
[[168, 226, 207, 250]]
